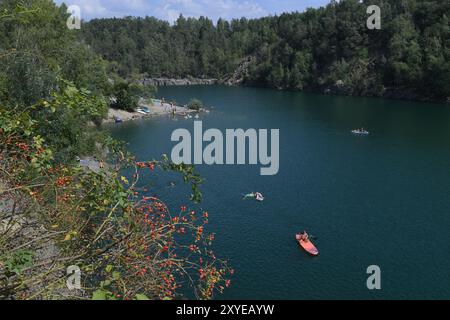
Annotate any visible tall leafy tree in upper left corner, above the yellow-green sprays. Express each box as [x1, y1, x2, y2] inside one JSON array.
[[0, 0, 107, 106]]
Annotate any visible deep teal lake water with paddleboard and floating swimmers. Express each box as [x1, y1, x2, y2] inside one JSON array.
[[111, 86, 450, 299]]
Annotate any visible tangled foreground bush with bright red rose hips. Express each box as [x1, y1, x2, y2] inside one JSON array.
[[0, 89, 230, 300]]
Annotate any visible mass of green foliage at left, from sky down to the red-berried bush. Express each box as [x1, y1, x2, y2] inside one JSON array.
[[0, 0, 108, 162]]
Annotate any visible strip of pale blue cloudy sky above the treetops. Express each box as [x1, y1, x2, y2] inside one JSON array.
[[55, 0, 330, 22]]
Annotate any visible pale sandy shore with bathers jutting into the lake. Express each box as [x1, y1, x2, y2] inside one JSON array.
[[104, 100, 197, 123]]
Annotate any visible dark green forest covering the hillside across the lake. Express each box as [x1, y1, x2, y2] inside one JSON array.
[[79, 0, 450, 100]]
